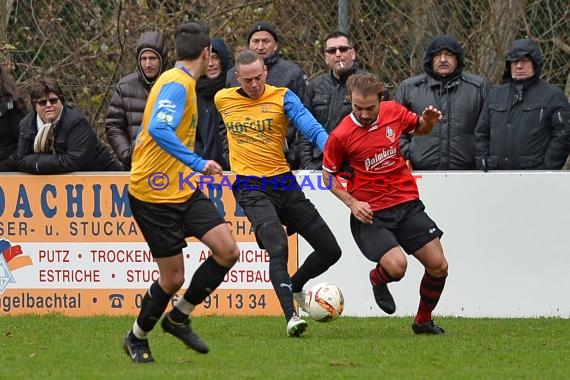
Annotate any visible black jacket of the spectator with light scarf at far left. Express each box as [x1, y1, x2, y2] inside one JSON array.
[[15, 105, 123, 174]]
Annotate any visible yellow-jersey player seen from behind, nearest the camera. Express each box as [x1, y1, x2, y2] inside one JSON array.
[[124, 23, 239, 363]]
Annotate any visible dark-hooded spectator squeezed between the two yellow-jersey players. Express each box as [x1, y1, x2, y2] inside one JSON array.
[[195, 38, 230, 170]]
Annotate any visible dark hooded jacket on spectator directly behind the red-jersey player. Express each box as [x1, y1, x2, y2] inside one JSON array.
[[395, 35, 488, 170]]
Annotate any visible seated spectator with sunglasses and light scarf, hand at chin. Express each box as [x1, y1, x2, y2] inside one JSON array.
[[15, 78, 122, 174]]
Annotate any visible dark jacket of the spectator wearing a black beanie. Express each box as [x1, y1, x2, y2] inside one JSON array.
[[224, 53, 309, 170]]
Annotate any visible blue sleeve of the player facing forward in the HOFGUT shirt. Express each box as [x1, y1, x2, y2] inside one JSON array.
[[283, 90, 329, 152]]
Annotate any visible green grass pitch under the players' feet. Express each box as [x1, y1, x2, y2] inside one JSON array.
[[0, 315, 570, 380]]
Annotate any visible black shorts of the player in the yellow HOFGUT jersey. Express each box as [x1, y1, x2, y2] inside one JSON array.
[[233, 172, 319, 242]]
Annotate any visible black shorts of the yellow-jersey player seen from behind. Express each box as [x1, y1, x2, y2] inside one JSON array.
[[129, 190, 225, 258]]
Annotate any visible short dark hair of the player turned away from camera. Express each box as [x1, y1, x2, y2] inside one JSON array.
[[174, 22, 210, 60]]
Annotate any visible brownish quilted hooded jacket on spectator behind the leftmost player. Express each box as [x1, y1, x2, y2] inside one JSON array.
[[105, 32, 168, 169]]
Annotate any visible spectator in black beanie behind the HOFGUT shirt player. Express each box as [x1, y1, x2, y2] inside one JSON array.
[[226, 21, 309, 170]]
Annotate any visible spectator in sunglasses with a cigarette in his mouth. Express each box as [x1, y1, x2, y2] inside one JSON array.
[[299, 31, 366, 170]]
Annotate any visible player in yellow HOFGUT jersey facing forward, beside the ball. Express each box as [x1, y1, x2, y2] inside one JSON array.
[[214, 49, 341, 336]]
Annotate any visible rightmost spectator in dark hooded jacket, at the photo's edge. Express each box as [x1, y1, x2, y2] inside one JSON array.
[[475, 39, 570, 171]]
